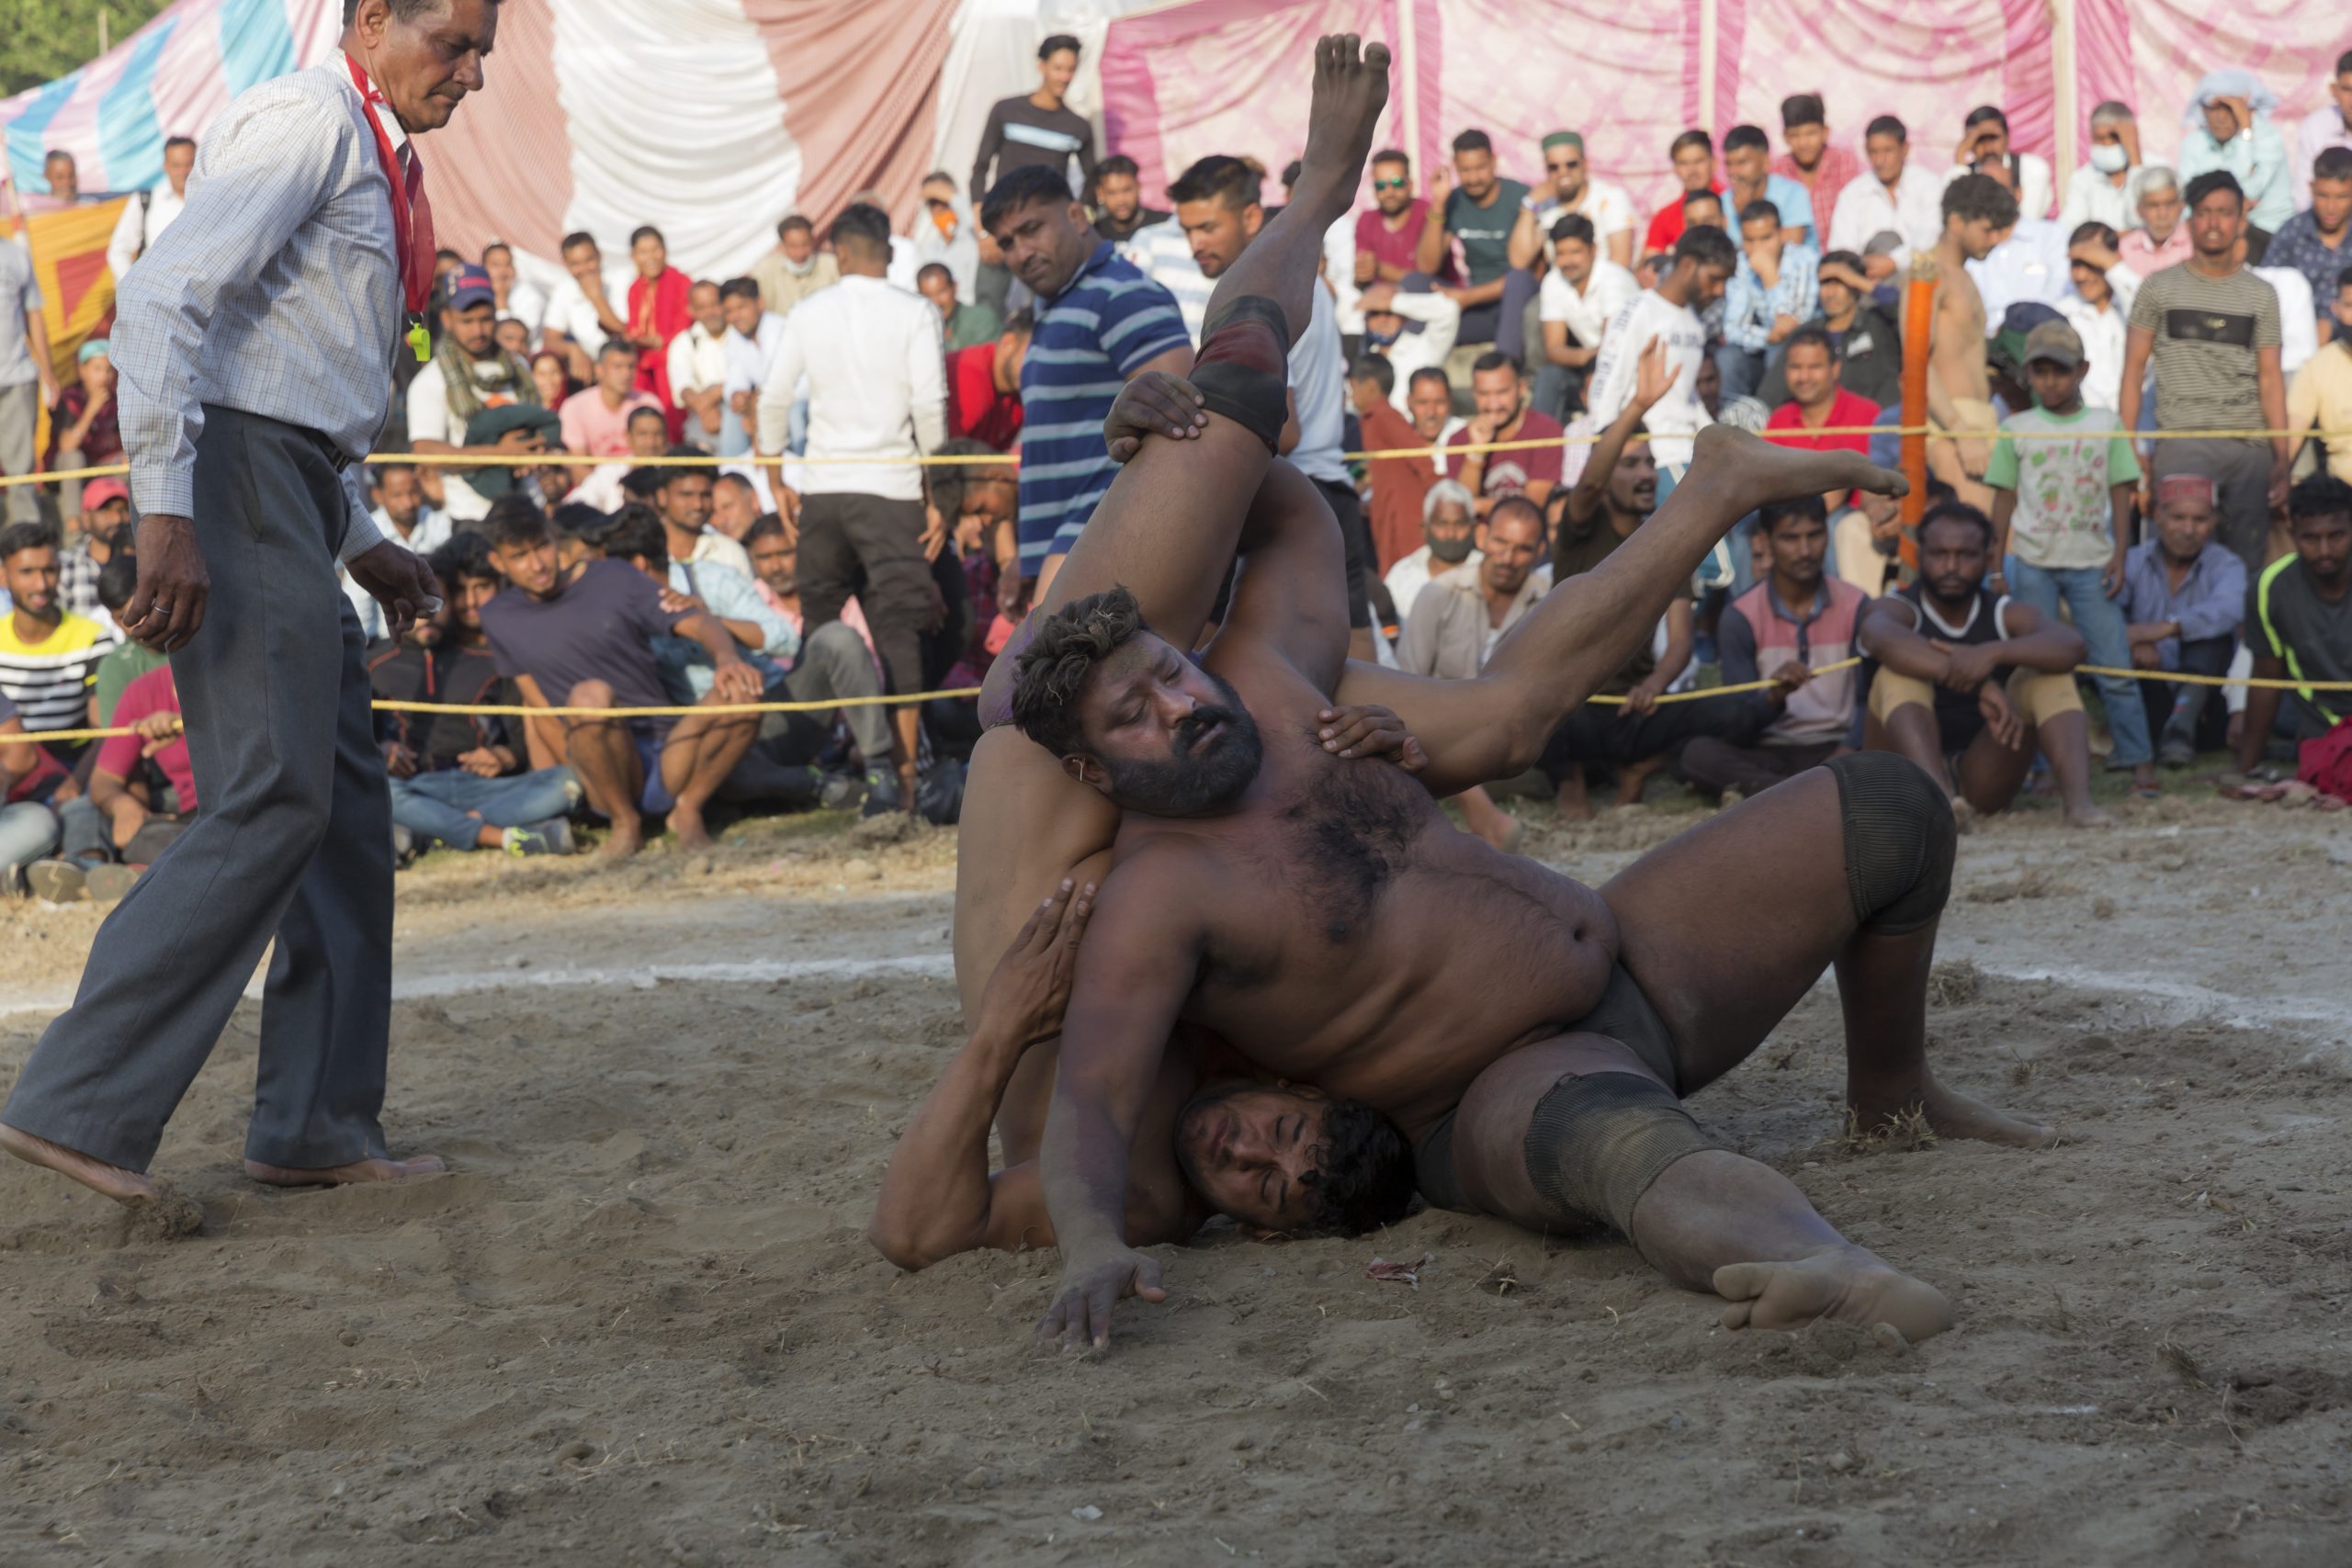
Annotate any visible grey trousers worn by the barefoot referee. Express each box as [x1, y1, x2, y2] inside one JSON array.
[[0, 404, 393, 1170]]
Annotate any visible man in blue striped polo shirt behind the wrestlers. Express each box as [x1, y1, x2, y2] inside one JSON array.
[[981, 167, 1193, 602]]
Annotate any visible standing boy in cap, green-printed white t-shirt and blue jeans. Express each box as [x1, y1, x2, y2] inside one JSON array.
[[1985, 322, 2157, 795]]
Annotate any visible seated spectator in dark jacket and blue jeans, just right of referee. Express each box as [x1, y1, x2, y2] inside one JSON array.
[[367, 534, 581, 856]]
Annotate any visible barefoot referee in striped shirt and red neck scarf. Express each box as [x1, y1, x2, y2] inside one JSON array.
[[0, 0, 499, 1203]]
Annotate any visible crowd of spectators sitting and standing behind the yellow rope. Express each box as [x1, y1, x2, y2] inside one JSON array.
[[0, 38, 2352, 898]]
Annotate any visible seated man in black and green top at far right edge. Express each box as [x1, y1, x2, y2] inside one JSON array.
[[2237, 475, 2352, 773]]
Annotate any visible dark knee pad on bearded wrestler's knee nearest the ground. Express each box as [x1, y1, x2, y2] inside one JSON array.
[[1524, 1072, 1724, 1236]]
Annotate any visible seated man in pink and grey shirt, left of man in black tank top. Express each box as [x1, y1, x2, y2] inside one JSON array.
[[1675, 496, 1870, 802]]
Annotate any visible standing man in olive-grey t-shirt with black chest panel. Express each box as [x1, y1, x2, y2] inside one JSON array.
[[2121, 172, 2293, 576]]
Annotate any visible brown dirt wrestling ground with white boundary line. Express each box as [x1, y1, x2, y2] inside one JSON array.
[[0, 802, 2352, 1568]]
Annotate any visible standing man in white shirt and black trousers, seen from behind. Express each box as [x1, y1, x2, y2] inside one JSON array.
[[757, 202, 948, 808]]
